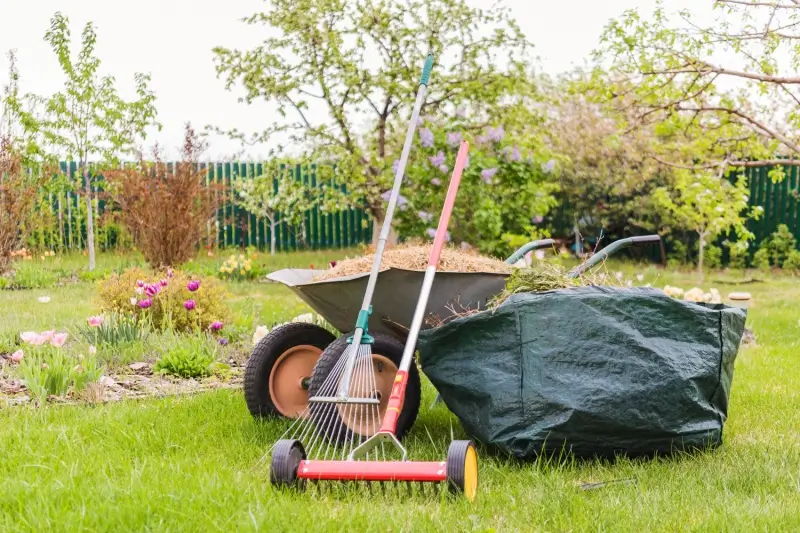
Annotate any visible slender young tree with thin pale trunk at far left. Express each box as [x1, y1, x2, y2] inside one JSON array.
[[16, 12, 161, 270]]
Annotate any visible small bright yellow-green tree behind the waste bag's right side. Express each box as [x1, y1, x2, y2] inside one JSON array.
[[653, 169, 763, 275]]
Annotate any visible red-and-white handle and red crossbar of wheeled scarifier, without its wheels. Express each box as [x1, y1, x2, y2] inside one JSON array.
[[297, 141, 469, 482]]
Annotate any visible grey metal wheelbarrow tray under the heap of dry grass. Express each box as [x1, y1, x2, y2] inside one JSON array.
[[267, 268, 509, 340]]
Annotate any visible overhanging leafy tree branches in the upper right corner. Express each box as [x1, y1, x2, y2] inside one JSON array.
[[597, 0, 800, 175]]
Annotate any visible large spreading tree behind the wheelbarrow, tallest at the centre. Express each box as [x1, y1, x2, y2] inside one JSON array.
[[214, 0, 534, 242]]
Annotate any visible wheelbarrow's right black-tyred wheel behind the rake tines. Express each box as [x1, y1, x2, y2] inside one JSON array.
[[308, 333, 422, 442]]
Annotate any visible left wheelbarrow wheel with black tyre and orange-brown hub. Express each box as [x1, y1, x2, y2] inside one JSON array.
[[243, 322, 336, 418]]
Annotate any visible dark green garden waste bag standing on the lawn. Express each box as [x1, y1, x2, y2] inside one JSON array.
[[418, 287, 747, 459]]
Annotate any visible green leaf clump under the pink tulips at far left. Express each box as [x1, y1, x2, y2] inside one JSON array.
[[19, 346, 103, 405]]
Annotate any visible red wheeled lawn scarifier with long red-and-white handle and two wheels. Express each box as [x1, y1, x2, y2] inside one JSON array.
[[270, 141, 478, 501]]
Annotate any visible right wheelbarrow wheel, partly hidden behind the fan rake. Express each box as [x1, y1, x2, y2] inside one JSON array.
[[308, 333, 422, 442]]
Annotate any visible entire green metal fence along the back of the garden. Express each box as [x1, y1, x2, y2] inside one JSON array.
[[28, 162, 800, 251]]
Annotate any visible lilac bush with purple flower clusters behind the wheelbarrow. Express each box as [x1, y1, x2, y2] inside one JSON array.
[[395, 115, 558, 256]]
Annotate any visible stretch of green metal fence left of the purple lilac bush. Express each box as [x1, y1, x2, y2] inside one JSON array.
[[32, 162, 372, 251]]
